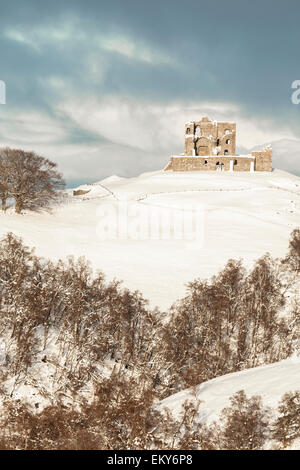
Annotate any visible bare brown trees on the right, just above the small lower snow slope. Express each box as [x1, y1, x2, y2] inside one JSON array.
[[163, 255, 296, 390]]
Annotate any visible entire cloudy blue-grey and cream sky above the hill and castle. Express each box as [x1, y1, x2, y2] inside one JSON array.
[[0, 0, 300, 184]]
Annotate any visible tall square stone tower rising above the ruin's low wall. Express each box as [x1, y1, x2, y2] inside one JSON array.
[[185, 117, 236, 156]]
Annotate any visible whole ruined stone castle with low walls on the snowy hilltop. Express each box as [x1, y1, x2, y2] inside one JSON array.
[[165, 117, 272, 172]]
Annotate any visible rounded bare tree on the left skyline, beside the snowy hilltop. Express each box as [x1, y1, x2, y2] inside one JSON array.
[[0, 148, 65, 213]]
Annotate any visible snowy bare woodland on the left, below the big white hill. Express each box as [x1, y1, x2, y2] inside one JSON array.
[[0, 234, 163, 390]]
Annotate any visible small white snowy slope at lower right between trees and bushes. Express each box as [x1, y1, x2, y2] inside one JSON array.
[[157, 358, 300, 423]]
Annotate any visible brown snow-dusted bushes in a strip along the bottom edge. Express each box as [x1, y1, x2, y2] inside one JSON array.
[[0, 384, 300, 450]]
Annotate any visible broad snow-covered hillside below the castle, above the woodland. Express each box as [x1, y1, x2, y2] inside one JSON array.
[[0, 170, 300, 309]]
